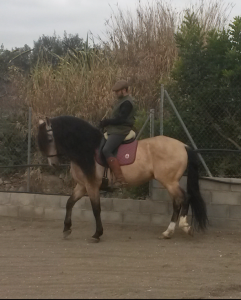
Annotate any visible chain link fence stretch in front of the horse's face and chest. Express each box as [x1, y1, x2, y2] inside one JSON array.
[[0, 105, 73, 195]]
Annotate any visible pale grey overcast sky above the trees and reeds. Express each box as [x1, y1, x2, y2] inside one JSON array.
[[0, 0, 241, 50]]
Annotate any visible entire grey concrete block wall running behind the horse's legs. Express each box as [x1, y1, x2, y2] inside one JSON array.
[[0, 177, 241, 228]]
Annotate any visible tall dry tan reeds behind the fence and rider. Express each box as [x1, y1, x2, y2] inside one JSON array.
[[15, 0, 232, 124]]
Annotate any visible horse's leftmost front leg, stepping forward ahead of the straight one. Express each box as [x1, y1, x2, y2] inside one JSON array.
[[63, 184, 86, 237]]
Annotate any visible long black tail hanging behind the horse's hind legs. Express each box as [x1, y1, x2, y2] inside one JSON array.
[[186, 147, 208, 231]]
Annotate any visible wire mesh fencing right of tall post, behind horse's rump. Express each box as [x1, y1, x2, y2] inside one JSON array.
[[164, 86, 241, 178]]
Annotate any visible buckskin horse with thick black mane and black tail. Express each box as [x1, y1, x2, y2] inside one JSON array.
[[37, 116, 208, 241]]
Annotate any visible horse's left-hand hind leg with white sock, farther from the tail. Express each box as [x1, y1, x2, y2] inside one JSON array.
[[162, 183, 185, 239]]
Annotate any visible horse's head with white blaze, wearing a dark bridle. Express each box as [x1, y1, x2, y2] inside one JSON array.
[[38, 118, 59, 166]]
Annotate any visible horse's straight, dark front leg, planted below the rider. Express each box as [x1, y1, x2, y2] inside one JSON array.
[[86, 186, 103, 240]]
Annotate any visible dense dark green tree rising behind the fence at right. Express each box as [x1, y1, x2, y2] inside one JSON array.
[[169, 12, 241, 177]]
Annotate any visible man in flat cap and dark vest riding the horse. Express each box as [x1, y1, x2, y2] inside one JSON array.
[[100, 80, 135, 187]]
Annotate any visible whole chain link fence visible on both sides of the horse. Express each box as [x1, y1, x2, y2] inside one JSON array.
[[0, 82, 241, 195]]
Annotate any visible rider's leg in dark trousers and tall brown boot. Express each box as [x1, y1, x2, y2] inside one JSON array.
[[102, 134, 127, 187]]
